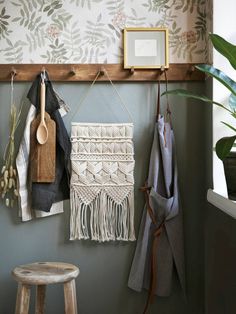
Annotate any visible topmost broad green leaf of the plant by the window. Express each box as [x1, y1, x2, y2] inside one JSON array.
[[210, 34, 236, 70]]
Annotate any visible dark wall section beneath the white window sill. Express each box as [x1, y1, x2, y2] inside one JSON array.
[[205, 202, 236, 314]]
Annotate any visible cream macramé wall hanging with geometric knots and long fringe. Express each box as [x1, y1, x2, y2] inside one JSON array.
[[70, 123, 135, 242]]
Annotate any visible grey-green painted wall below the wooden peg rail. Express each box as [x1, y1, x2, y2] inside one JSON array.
[[0, 83, 211, 314]]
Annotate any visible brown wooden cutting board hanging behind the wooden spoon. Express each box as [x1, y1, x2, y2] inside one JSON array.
[[30, 112, 56, 183]]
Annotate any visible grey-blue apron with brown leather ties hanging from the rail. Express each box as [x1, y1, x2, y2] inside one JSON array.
[[128, 115, 185, 296]]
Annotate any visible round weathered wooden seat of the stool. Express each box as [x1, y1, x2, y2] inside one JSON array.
[[12, 262, 79, 285]]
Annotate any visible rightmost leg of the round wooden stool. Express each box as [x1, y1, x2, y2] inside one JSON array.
[[64, 279, 77, 314]]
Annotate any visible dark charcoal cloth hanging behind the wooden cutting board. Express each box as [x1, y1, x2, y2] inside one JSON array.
[[25, 72, 71, 212]]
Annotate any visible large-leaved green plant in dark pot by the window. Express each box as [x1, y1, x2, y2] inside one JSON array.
[[162, 34, 236, 200]]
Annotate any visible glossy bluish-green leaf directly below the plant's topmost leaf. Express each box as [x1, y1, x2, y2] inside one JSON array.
[[196, 64, 236, 95]]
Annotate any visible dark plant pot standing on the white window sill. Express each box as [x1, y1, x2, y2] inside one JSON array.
[[223, 152, 236, 201]]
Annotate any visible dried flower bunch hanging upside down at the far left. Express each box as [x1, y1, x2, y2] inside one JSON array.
[[0, 105, 21, 207]]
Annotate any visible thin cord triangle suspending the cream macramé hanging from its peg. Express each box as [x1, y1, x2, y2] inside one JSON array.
[[70, 70, 133, 122]]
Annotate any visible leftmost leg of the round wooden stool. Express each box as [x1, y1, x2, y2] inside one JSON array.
[[15, 283, 30, 314]]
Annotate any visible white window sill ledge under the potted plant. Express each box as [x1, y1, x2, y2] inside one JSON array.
[[207, 189, 236, 219]]
